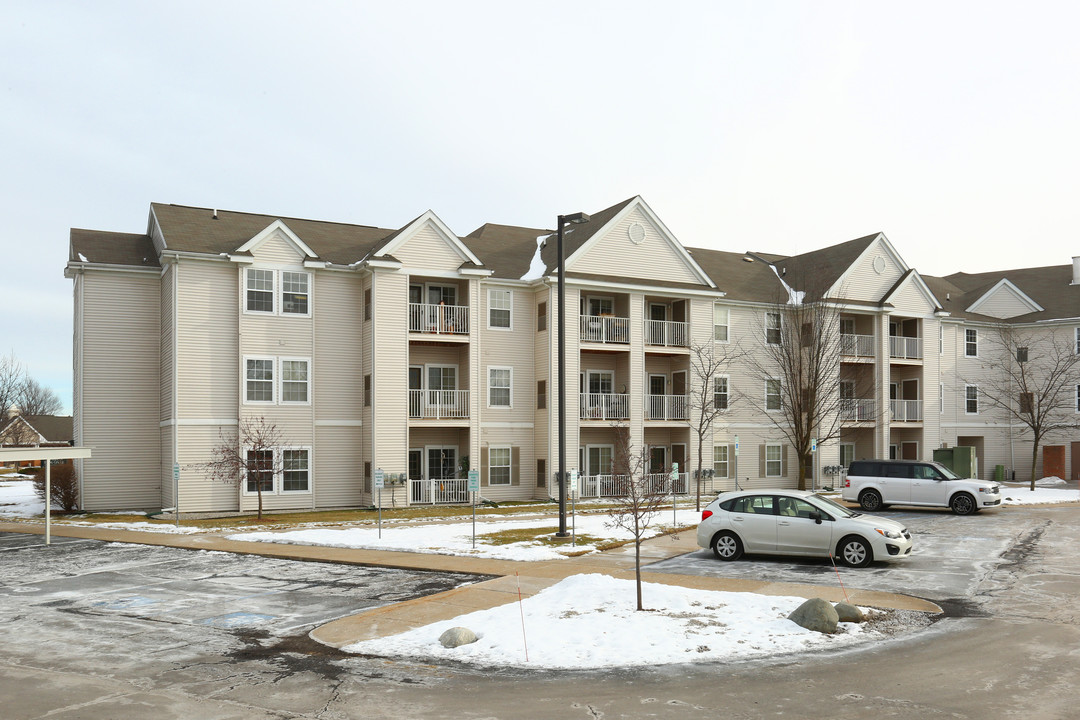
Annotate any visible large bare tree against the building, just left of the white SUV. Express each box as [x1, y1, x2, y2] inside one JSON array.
[[746, 281, 846, 490]]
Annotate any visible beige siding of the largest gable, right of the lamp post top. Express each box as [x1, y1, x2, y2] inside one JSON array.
[[566, 209, 701, 283]]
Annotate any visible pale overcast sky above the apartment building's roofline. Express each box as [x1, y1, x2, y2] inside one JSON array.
[[0, 0, 1080, 408]]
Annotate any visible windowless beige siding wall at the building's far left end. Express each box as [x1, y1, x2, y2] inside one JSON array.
[[80, 271, 161, 511]]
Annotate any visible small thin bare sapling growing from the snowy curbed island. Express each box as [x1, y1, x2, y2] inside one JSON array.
[[606, 425, 667, 610]]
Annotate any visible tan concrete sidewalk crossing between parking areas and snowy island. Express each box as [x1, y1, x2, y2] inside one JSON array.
[[0, 522, 942, 648]]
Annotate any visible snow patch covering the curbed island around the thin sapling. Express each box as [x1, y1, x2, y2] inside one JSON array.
[[343, 574, 894, 669]]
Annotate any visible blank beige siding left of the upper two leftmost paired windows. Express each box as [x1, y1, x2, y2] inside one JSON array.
[[176, 262, 240, 418]]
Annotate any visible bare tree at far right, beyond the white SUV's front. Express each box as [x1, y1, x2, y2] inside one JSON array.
[[971, 325, 1080, 491]]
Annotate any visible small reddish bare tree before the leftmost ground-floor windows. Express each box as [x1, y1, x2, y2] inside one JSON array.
[[192, 417, 285, 520]]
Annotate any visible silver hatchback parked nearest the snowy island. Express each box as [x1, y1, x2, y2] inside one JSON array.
[[698, 490, 912, 568]]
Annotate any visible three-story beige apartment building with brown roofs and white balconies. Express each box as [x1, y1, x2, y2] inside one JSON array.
[[66, 198, 1080, 512]]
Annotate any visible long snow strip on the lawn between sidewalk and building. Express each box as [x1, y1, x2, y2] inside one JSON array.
[[228, 510, 701, 561]]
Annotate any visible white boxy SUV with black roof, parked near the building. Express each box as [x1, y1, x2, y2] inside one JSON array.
[[840, 460, 1001, 515]]
